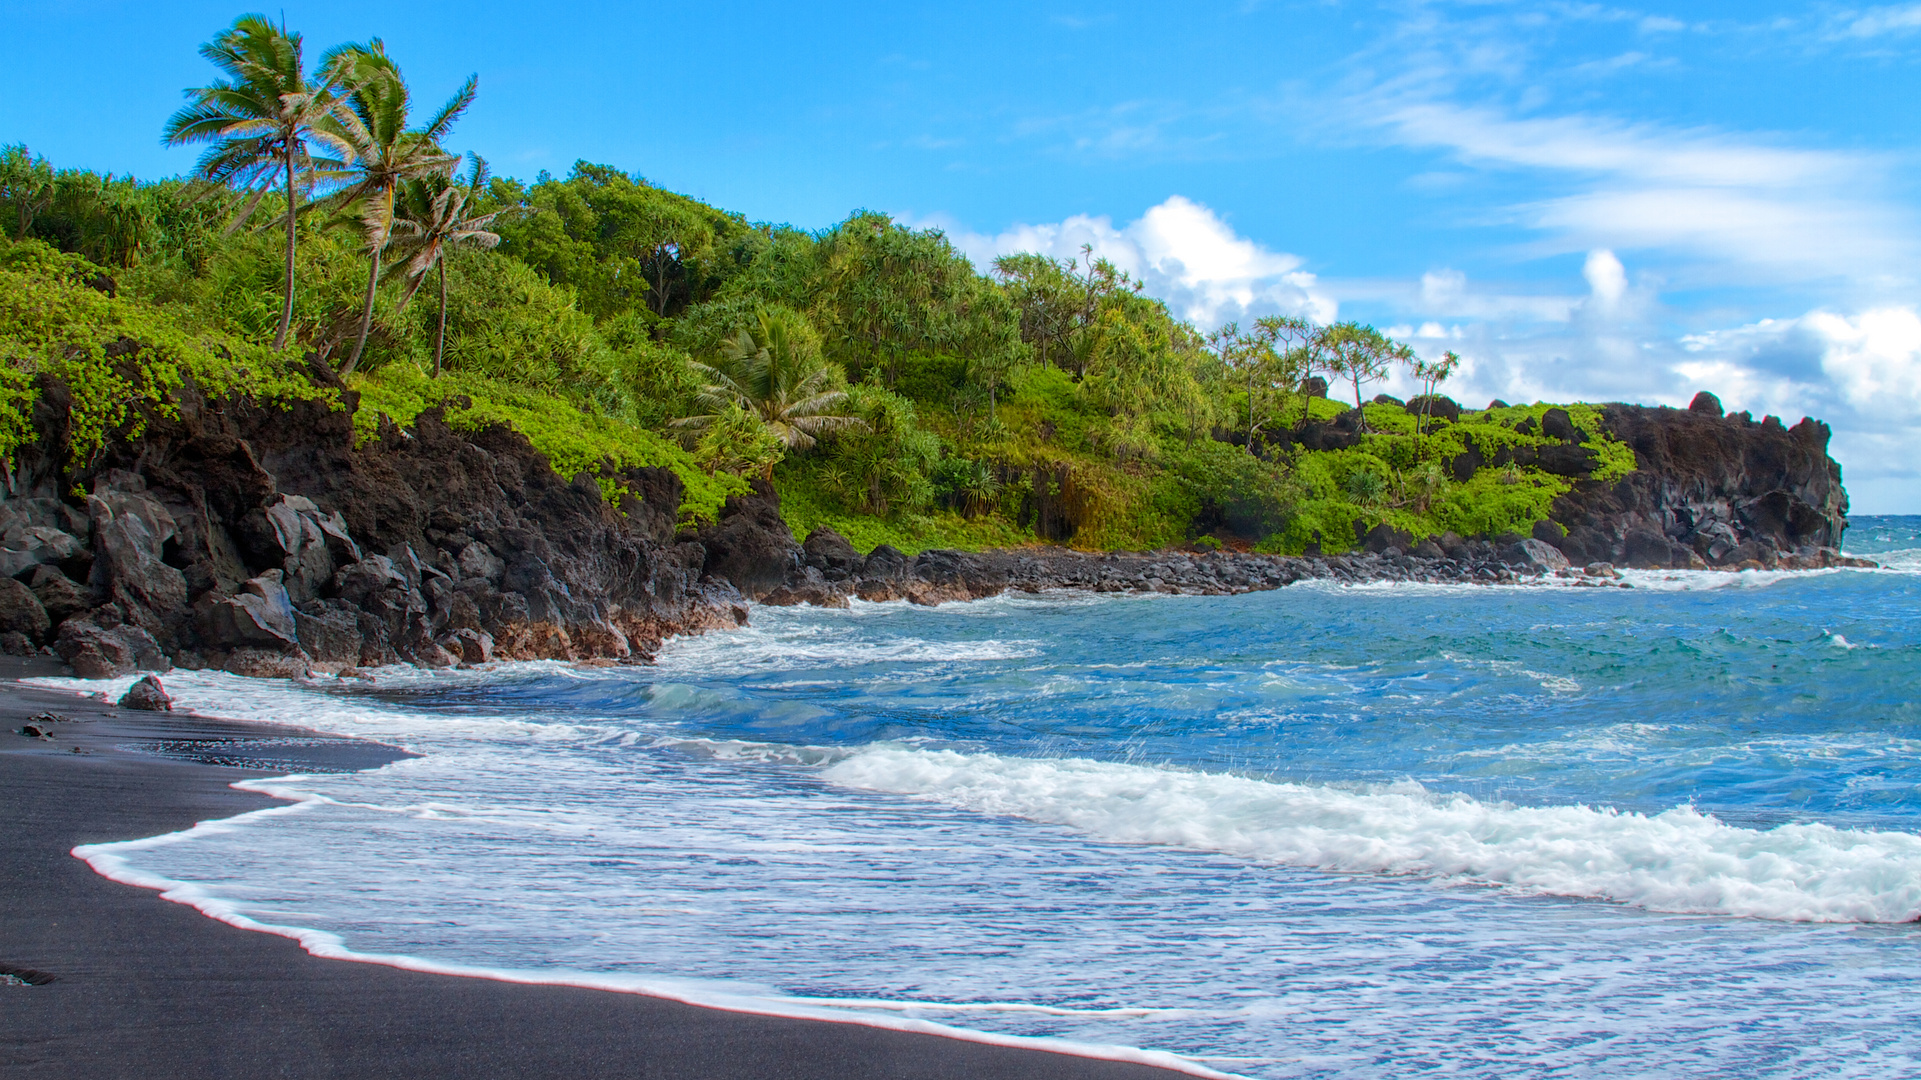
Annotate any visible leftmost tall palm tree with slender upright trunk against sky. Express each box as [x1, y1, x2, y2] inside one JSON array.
[[165, 15, 346, 350]]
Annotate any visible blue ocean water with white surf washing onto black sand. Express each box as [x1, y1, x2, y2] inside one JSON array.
[[42, 517, 1921, 1078]]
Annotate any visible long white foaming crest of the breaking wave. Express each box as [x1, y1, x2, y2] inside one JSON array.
[[824, 746, 1921, 922]]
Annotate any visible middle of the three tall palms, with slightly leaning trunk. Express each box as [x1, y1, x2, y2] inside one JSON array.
[[321, 38, 478, 377]]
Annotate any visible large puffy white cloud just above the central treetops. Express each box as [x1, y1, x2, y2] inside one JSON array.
[[949, 196, 1339, 327]]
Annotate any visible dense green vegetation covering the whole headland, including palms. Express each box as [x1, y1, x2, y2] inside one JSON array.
[[0, 17, 1633, 552]]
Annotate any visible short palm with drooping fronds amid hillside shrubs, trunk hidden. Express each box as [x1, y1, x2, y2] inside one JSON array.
[[672, 307, 861, 450]]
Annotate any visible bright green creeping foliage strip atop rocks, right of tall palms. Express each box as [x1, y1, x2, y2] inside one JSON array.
[[350, 363, 747, 521]]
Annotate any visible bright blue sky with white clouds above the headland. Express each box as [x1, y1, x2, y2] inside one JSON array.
[[11, 0, 1921, 513]]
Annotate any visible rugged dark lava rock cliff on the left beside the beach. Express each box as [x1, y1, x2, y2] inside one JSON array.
[[0, 371, 749, 676]]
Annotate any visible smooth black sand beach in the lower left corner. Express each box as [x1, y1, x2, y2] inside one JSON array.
[[0, 659, 1174, 1080]]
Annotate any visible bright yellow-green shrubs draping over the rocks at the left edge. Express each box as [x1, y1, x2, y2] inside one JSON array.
[[0, 240, 330, 467]]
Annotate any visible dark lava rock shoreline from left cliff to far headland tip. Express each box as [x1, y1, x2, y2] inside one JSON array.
[[0, 369, 1871, 678]]
